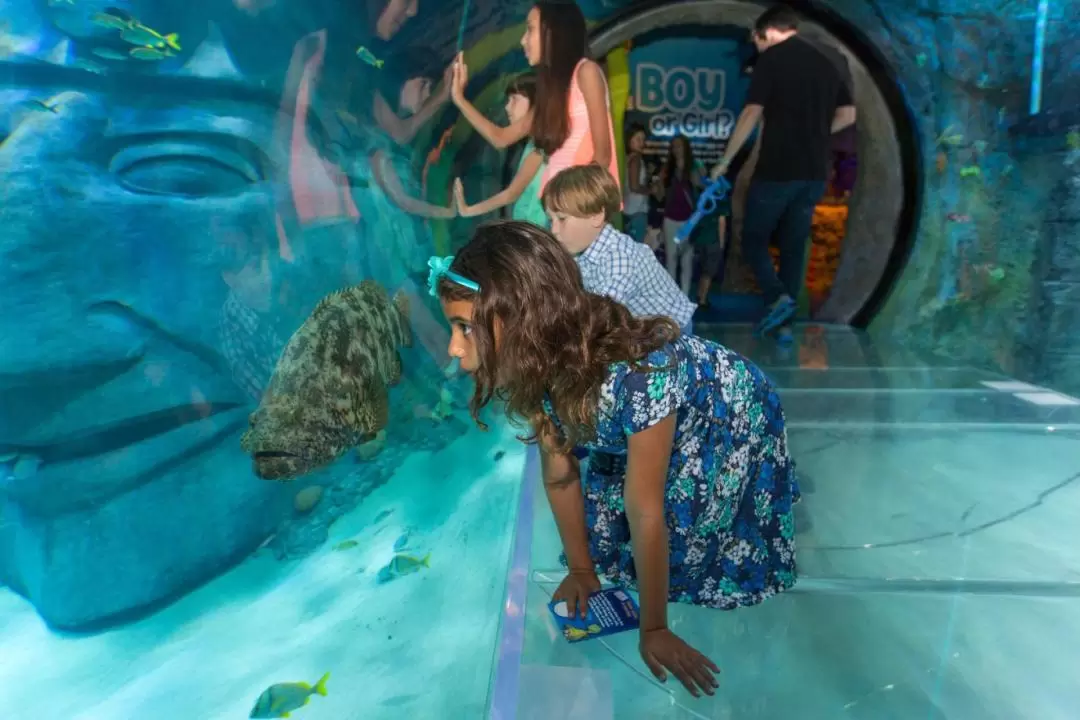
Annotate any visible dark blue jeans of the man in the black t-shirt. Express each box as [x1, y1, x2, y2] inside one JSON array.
[[742, 180, 825, 305]]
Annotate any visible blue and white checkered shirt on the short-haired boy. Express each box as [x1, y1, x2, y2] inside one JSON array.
[[577, 225, 697, 327]]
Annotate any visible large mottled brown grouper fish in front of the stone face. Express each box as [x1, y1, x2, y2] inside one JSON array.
[[240, 280, 413, 480]]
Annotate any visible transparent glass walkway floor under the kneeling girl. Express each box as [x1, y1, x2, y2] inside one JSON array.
[[503, 327, 1080, 720]]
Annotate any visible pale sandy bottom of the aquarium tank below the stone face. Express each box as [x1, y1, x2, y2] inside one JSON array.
[[0, 418, 524, 720]]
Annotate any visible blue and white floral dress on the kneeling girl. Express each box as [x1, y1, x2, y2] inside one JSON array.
[[546, 336, 799, 610]]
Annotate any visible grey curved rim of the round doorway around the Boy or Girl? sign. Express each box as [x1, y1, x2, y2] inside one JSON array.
[[591, 0, 918, 325]]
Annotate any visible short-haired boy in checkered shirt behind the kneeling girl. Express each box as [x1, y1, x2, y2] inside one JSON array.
[[543, 165, 693, 335]]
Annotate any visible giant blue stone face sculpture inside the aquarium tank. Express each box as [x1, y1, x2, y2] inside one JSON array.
[[0, 0, 430, 630]]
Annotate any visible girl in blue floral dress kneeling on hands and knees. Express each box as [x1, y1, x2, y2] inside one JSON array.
[[429, 221, 798, 695]]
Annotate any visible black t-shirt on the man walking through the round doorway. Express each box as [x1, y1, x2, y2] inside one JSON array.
[[746, 36, 852, 181]]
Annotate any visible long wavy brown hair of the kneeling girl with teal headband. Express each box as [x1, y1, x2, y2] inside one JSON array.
[[438, 220, 679, 452]]
